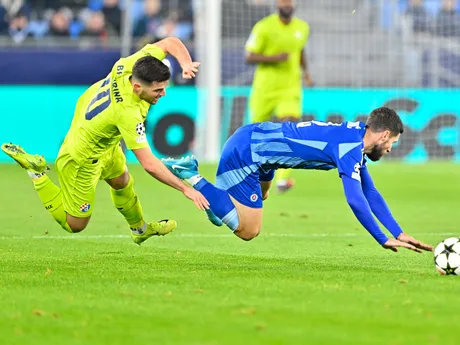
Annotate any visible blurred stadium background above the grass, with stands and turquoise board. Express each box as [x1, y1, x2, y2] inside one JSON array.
[[0, 0, 460, 162]]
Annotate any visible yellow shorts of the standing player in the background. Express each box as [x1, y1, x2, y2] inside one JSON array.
[[249, 91, 302, 123]]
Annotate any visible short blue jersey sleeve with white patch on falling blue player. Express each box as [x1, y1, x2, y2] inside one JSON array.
[[336, 142, 365, 182]]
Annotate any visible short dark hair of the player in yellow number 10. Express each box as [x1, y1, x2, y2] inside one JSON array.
[[133, 56, 171, 84]]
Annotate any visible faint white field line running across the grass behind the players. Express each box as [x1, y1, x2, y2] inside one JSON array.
[[0, 232, 454, 240]]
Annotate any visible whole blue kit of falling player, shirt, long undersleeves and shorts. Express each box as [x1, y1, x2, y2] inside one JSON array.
[[216, 121, 402, 244]]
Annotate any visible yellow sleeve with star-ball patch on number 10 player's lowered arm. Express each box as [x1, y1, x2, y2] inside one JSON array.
[[117, 107, 149, 150]]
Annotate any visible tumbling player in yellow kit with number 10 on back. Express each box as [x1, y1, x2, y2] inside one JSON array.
[[2, 38, 209, 244]]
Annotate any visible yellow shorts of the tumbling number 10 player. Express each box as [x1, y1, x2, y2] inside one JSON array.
[[56, 144, 126, 218]]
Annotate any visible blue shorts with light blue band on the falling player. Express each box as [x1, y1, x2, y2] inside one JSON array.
[[216, 124, 273, 208]]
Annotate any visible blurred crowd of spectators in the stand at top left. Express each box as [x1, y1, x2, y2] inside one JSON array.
[[0, 0, 194, 44]]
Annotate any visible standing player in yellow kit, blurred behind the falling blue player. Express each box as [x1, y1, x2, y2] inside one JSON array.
[[246, 0, 313, 192]]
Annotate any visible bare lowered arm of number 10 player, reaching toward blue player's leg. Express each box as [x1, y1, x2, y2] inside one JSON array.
[[133, 148, 209, 210]]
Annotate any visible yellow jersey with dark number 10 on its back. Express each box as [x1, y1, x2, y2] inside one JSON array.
[[63, 44, 166, 163]]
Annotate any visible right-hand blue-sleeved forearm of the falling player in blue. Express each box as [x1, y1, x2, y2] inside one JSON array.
[[361, 169, 403, 238]]
